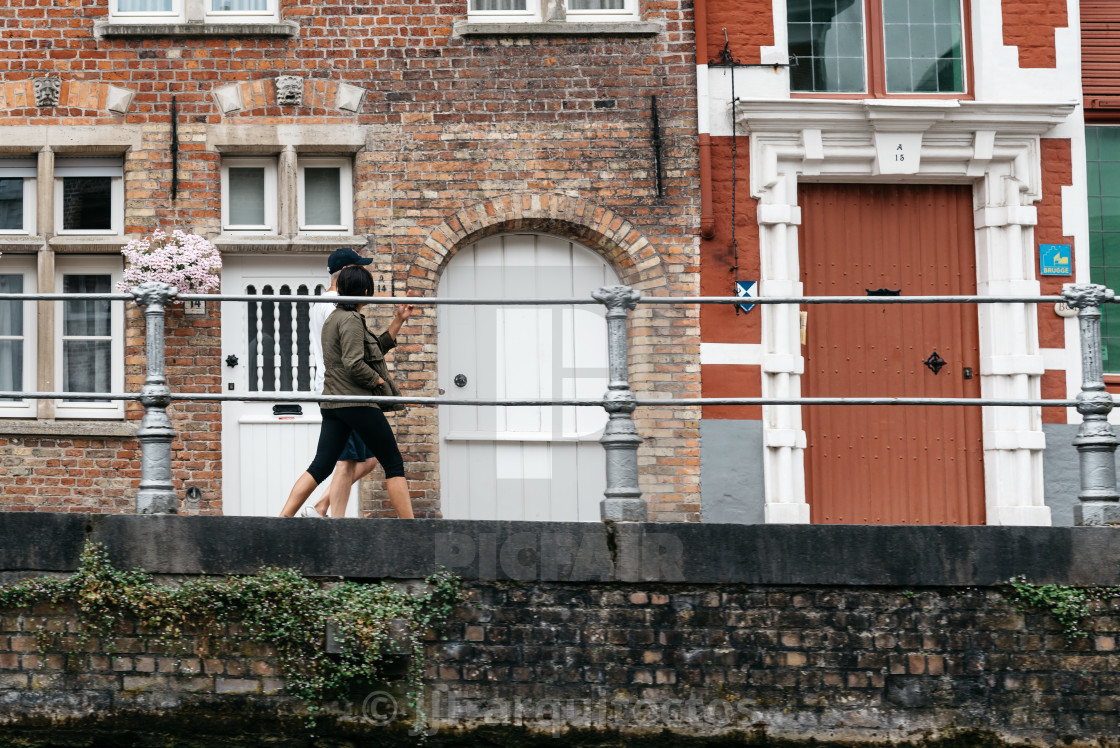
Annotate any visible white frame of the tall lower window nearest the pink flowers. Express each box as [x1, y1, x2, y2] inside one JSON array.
[[54, 255, 124, 419]]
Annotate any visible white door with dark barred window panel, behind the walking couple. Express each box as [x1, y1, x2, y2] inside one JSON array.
[[222, 254, 358, 517]]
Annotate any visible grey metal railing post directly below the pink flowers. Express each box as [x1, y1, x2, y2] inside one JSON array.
[[132, 282, 179, 514]]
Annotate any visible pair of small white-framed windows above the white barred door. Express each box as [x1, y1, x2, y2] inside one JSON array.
[[222, 156, 354, 234]]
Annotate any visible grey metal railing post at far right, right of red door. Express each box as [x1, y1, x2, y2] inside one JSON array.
[[1062, 283, 1120, 525]]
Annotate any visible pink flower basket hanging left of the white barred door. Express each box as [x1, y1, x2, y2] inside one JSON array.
[[116, 228, 222, 293]]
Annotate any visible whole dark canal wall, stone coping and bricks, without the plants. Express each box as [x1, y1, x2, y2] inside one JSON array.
[[0, 514, 1120, 747]]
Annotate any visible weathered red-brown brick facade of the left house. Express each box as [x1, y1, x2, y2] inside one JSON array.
[[0, 0, 699, 520]]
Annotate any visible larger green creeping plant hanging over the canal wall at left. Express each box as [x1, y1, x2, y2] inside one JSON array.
[[0, 543, 461, 729]]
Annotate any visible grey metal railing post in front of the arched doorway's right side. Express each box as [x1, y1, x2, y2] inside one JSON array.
[[591, 286, 646, 522]]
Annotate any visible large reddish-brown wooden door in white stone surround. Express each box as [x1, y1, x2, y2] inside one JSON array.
[[800, 185, 984, 524]]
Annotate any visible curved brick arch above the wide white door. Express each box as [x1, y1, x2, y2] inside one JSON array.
[[416, 194, 668, 293]]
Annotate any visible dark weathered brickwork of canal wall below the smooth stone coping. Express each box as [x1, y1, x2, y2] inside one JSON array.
[[0, 582, 1120, 746]]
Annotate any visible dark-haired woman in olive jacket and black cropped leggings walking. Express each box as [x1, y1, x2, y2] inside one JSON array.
[[280, 265, 412, 518]]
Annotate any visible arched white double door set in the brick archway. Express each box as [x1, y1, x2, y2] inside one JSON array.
[[439, 234, 619, 522]]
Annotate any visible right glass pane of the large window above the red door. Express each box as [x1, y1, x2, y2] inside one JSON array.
[[883, 0, 964, 93]]
